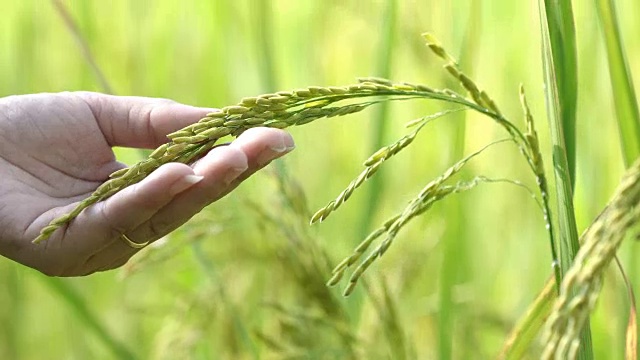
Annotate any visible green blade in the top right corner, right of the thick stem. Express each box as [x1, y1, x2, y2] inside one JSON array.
[[596, 0, 640, 168]]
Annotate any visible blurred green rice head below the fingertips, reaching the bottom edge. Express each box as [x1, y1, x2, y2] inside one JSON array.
[[251, 171, 360, 358]]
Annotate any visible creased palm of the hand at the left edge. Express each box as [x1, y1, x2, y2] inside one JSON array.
[[0, 95, 122, 238]]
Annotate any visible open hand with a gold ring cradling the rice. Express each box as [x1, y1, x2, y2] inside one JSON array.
[[0, 92, 294, 276]]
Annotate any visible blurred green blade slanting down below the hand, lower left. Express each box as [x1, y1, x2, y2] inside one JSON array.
[[37, 275, 136, 359]]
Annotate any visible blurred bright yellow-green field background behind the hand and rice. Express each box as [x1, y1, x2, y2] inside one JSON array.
[[0, 0, 640, 359]]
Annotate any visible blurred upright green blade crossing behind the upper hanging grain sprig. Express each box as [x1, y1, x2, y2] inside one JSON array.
[[360, 0, 398, 236]]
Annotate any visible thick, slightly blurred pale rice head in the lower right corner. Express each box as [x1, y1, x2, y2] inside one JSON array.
[[543, 161, 640, 359]]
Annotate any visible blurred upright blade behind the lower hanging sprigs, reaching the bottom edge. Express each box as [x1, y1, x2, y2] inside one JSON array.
[[438, 0, 482, 360]]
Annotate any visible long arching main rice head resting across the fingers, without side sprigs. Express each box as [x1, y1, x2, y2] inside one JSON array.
[[34, 79, 523, 243]]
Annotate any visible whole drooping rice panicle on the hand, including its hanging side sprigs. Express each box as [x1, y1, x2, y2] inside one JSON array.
[[34, 34, 555, 306]]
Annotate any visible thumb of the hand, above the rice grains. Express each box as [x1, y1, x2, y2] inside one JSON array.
[[75, 92, 214, 148]]
